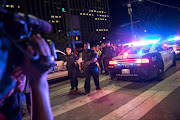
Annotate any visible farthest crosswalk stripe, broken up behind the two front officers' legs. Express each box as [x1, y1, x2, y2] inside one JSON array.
[[49, 76, 109, 98]]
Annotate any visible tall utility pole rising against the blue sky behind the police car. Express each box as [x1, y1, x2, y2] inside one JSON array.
[[127, 0, 134, 40]]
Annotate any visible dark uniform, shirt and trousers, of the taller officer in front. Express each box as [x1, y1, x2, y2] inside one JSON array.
[[82, 49, 99, 93]]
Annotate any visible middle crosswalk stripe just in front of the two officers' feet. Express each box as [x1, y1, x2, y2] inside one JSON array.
[[52, 82, 132, 117]]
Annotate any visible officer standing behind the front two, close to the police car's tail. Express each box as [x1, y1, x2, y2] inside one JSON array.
[[102, 41, 115, 75]]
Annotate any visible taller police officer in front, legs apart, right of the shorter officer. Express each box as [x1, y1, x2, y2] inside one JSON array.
[[82, 43, 100, 94]]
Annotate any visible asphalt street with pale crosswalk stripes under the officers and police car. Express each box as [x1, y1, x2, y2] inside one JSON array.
[[23, 61, 180, 120]]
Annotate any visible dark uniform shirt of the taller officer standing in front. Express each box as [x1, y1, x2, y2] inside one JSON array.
[[82, 49, 98, 64]]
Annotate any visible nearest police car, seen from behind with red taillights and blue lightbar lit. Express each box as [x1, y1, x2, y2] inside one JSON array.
[[108, 41, 176, 80]]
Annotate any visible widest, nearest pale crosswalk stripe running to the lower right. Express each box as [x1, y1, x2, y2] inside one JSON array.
[[100, 71, 180, 120]]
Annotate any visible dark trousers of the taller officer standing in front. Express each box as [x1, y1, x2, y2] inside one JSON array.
[[84, 65, 99, 92]]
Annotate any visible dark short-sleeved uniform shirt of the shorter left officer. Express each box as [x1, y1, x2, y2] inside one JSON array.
[[64, 53, 79, 69]]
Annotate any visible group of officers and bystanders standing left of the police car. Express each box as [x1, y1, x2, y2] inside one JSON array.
[[60, 41, 122, 94]]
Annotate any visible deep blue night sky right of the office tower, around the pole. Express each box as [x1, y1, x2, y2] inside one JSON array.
[[109, 0, 180, 39]]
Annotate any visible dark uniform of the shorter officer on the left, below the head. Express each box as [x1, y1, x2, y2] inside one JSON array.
[[64, 54, 79, 88]]
